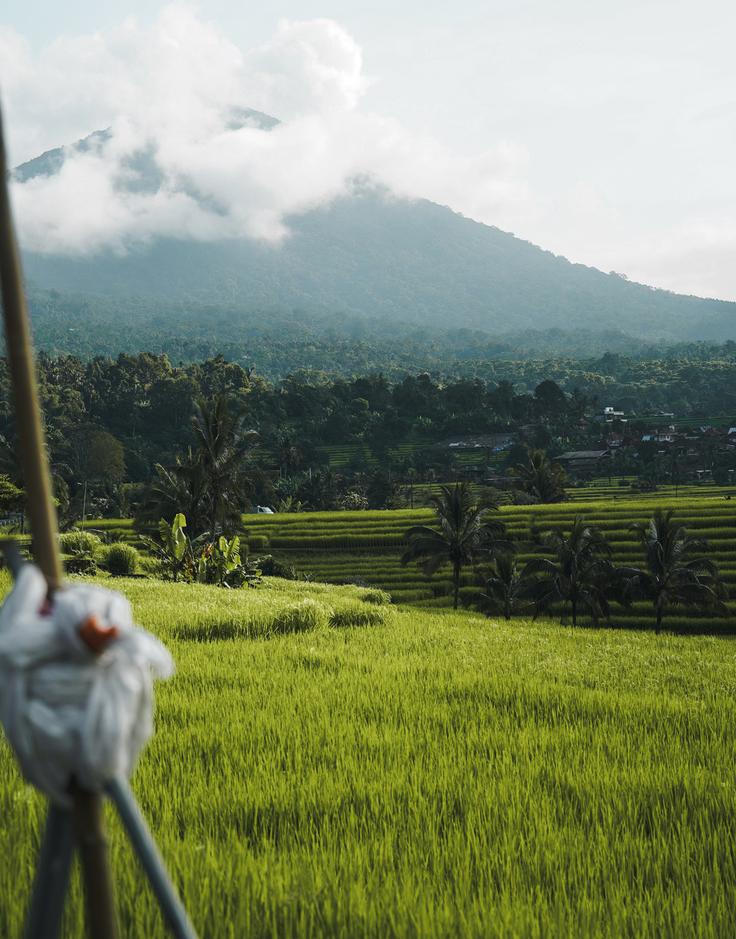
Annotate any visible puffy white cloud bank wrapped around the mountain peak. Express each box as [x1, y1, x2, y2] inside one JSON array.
[[0, 4, 530, 255]]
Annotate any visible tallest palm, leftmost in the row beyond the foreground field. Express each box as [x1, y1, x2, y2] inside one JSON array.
[[401, 483, 505, 609]]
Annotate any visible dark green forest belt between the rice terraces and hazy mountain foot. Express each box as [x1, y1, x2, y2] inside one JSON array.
[[0, 343, 736, 515]]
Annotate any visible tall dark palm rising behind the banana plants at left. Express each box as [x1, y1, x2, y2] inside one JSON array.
[[192, 395, 257, 538]]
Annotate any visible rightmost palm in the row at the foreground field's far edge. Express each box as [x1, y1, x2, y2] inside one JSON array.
[[621, 509, 728, 633]]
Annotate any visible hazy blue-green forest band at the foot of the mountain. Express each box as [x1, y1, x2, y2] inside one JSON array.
[[15, 287, 736, 390]]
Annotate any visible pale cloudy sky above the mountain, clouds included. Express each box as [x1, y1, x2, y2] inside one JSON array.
[[0, 0, 736, 299]]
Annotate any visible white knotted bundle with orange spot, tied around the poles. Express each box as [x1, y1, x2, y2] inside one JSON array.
[[0, 564, 174, 807]]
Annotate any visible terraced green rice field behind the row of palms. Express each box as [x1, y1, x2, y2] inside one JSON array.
[[83, 487, 736, 633]]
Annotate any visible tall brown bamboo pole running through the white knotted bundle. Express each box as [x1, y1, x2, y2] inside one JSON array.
[[0, 103, 117, 939]]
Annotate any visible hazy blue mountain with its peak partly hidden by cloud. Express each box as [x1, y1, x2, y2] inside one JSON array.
[[15, 126, 736, 354]]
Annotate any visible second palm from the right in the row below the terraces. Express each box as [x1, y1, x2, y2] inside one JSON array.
[[524, 515, 613, 626]]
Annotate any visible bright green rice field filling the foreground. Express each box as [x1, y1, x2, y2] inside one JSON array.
[[0, 576, 736, 939]]
